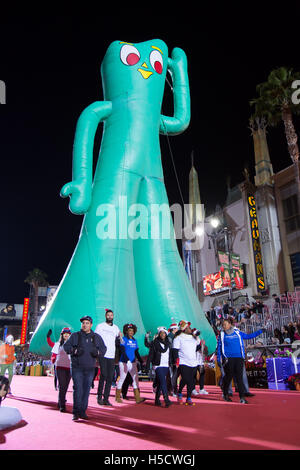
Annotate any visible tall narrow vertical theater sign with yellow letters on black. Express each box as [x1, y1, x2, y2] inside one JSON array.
[[248, 195, 266, 293]]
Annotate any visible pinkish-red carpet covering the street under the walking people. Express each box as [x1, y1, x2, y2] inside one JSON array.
[[0, 375, 300, 451]]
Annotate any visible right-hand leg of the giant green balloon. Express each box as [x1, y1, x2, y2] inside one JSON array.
[[133, 178, 216, 353]]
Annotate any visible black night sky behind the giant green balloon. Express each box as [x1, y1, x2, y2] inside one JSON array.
[[0, 9, 300, 303]]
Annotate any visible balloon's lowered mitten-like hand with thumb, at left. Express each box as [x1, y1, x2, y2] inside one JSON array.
[[60, 180, 92, 215]]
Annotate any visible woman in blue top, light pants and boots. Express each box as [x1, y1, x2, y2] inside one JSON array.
[[116, 323, 145, 403]]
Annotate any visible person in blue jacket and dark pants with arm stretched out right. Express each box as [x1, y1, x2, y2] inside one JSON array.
[[217, 317, 265, 403]]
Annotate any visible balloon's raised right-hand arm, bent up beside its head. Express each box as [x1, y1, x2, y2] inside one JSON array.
[[160, 47, 191, 135]]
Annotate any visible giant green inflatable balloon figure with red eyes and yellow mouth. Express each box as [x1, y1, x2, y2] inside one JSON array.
[[30, 39, 216, 354]]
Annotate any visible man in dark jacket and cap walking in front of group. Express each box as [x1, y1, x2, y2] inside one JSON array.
[[63, 315, 106, 421]]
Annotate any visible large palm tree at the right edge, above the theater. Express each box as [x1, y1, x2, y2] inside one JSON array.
[[250, 67, 300, 205]]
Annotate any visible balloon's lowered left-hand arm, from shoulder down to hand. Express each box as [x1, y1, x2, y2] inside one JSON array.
[[60, 101, 112, 214]]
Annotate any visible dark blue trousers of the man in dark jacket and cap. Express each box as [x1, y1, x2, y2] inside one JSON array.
[[71, 367, 95, 414]]
